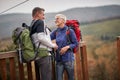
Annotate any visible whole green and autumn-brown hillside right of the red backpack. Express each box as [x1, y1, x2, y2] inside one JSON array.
[[81, 19, 120, 80]]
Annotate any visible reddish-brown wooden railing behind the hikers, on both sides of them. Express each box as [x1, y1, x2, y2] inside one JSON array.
[[0, 43, 89, 80]]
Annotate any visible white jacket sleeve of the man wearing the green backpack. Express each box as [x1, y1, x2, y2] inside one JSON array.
[[37, 32, 55, 48]]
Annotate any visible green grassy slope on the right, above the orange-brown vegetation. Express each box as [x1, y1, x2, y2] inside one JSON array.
[[81, 19, 120, 41]]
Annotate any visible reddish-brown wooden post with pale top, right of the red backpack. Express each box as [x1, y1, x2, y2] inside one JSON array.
[[80, 42, 89, 80]]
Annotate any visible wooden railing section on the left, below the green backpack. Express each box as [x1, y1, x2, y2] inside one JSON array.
[[0, 51, 33, 80]]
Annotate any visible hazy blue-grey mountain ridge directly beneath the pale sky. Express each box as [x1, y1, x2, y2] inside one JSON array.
[[0, 5, 120, 38]]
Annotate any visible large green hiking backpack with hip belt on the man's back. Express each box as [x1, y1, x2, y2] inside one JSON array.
[[12, 27, 48, 63]]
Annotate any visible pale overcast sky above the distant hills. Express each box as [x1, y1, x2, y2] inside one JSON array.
[[0, 0, 120, 14]]
